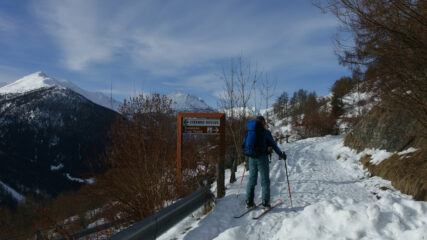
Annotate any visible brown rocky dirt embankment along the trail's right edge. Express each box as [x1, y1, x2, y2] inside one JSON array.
[[344, 107, 427, 201]]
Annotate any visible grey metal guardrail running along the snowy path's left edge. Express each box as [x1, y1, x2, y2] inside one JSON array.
[[111, 185, 214, 240]]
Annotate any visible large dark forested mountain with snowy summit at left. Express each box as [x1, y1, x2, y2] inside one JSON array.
[[0, 72, 118, 205]]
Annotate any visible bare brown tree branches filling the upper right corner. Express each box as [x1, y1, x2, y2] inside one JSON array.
[[315, 0, 427, 134]]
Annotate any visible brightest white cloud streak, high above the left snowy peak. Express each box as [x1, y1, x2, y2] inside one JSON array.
[[36, 0, 120, 70]]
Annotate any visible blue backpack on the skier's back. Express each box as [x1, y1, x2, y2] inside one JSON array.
[[244, 120, 264, 157]]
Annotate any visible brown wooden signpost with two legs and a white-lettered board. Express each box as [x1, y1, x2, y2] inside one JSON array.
[[176, 113, 225, 198]]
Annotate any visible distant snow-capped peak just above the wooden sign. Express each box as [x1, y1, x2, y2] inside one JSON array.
[[168, 91, 216, 112]]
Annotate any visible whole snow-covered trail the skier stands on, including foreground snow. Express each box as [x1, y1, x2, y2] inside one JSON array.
[[159, 136, 427, 240]]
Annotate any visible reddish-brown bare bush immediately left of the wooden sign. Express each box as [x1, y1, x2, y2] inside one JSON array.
[[94, 94, 176, 220]]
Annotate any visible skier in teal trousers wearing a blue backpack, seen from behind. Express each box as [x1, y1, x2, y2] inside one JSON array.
[[243, 116, 286, 209]]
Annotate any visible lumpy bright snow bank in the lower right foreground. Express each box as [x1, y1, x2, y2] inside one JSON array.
[[272, 197, 427, 239]]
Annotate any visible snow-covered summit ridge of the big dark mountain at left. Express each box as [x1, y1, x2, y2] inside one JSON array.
[[0, 71, 119, 111]]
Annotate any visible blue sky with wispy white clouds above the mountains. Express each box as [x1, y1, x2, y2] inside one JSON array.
[[0, 0, 350, 107]]
